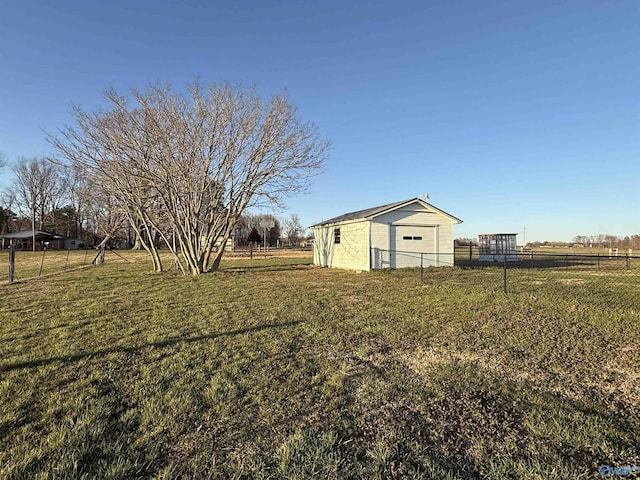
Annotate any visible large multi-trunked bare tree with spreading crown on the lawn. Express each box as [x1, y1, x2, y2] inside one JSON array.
[[49, 83, 328, 274]]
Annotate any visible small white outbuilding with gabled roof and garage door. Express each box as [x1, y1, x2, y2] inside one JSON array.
[[311, 198, 462, 271]]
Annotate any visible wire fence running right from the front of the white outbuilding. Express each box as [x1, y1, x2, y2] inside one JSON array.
[[371, 248, 640, 295]]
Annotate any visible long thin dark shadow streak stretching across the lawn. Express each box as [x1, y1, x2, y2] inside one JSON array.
[[0, 320, 302, 372]]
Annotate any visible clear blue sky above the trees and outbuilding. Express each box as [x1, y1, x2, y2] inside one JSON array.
[[0, 0, 640, 241]]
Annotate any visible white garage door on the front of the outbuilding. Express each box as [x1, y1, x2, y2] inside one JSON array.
[[390, 225, 437, 268]]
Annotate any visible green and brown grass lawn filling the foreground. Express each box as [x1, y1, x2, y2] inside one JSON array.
[[0, 252, 640, 479]]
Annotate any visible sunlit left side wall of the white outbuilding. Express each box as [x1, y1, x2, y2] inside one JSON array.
[[313, 220, 369, 270]]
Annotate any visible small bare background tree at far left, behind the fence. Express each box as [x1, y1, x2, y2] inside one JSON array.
[[13, 157, 64, 251]]
